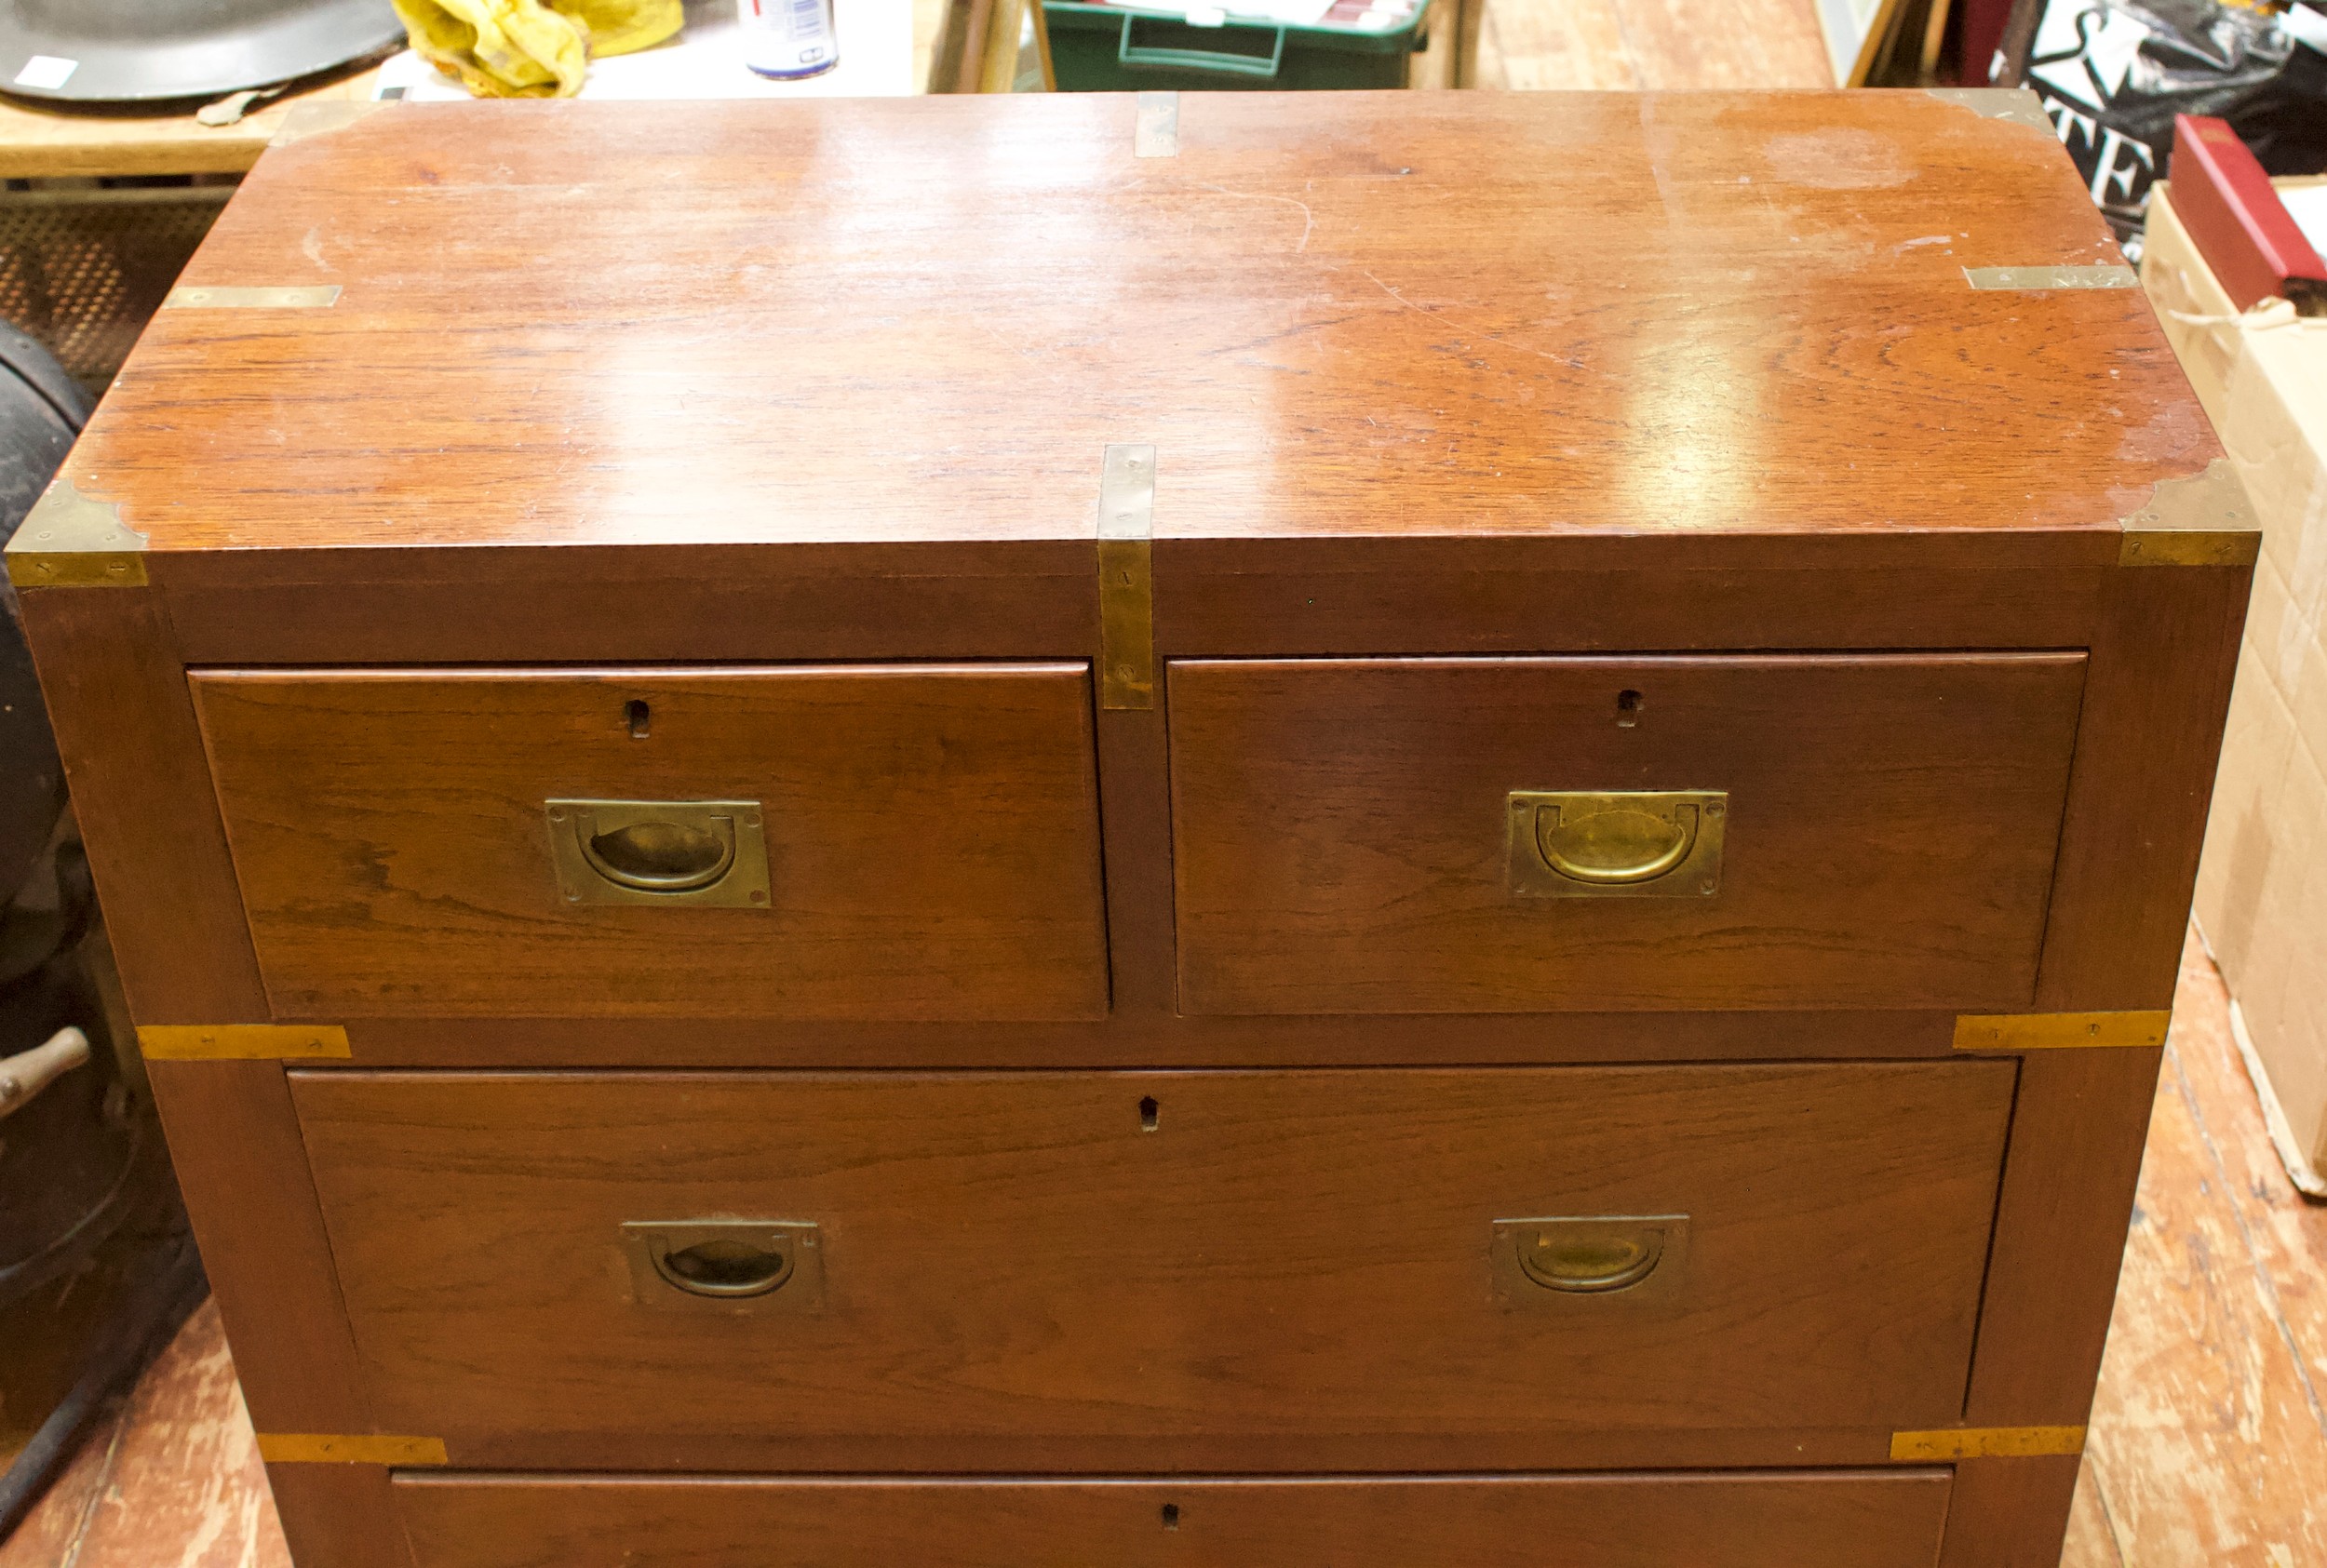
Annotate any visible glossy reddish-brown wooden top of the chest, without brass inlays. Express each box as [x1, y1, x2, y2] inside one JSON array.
[[49, 91, 2220, 552]]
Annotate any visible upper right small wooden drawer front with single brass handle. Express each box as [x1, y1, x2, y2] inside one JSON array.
[[1168, 651, 2085, 1014]]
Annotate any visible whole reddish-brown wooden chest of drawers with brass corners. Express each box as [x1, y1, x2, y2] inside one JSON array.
[[9, 93, 2255, 1568]]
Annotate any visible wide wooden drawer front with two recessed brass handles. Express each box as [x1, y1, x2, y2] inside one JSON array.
[[293, 1061, 2015, 1468]]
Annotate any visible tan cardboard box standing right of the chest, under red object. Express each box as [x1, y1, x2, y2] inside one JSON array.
[[2141, 180, 2327, 1199]]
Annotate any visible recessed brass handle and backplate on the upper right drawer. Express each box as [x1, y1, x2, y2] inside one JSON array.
[[1503, 789, 1729, 898]]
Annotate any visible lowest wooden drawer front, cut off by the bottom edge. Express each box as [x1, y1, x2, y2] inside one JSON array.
[[396, 1470, 1950, 1568]]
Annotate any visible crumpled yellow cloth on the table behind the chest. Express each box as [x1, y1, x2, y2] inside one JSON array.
[[394, 0, 687, 98]]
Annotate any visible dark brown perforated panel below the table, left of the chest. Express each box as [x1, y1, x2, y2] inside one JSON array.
[[0, 186, 233, 394]]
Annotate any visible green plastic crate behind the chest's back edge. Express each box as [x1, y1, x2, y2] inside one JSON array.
[[1042, 0, 1433, 93]]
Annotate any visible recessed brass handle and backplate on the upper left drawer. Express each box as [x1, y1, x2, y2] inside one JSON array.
[[543, 800, 768, 910]]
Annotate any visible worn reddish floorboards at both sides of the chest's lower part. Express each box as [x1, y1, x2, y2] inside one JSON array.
[[0, 921, 2327, 1568]]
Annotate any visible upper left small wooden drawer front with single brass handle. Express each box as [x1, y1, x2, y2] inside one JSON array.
[[191, 663, 1108, 1022]]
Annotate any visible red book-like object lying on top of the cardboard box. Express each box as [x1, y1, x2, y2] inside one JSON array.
[[2167, 114, 2327, 316]]
